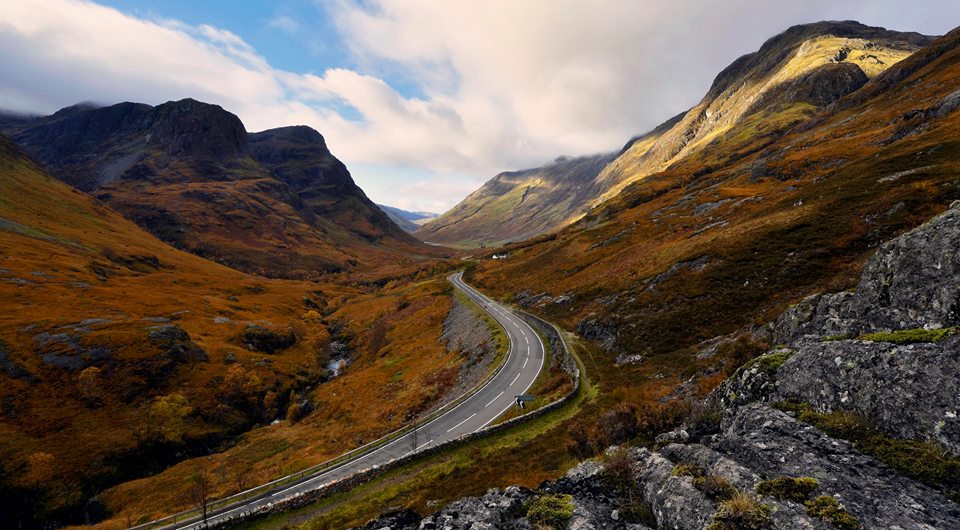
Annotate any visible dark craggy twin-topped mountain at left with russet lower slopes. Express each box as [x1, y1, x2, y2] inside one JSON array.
[[3, 99, 450, 278]]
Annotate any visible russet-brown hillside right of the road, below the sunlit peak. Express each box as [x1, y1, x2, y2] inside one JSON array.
[[473, 25, 960, 416]]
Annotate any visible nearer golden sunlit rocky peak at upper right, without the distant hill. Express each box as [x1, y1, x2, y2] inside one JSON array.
[[593, 21, 931, 205]]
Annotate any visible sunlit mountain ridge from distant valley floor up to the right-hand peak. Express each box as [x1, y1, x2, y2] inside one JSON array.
[[418, 21, 931, 244]]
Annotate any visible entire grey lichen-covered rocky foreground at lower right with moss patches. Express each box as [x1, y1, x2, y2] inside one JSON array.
[[356, 201, 960, 530]]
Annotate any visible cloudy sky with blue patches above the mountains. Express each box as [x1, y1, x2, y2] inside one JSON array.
[[0, 0, 960, 212]]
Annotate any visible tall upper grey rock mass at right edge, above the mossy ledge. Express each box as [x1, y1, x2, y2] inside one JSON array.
[[756, 202, 960, 453]]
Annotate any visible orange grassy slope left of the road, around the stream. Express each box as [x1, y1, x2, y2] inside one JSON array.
[[0, 138, 461, 527]]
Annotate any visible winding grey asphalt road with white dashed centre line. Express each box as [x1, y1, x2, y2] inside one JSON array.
[[161, 273, 545, 529]]
